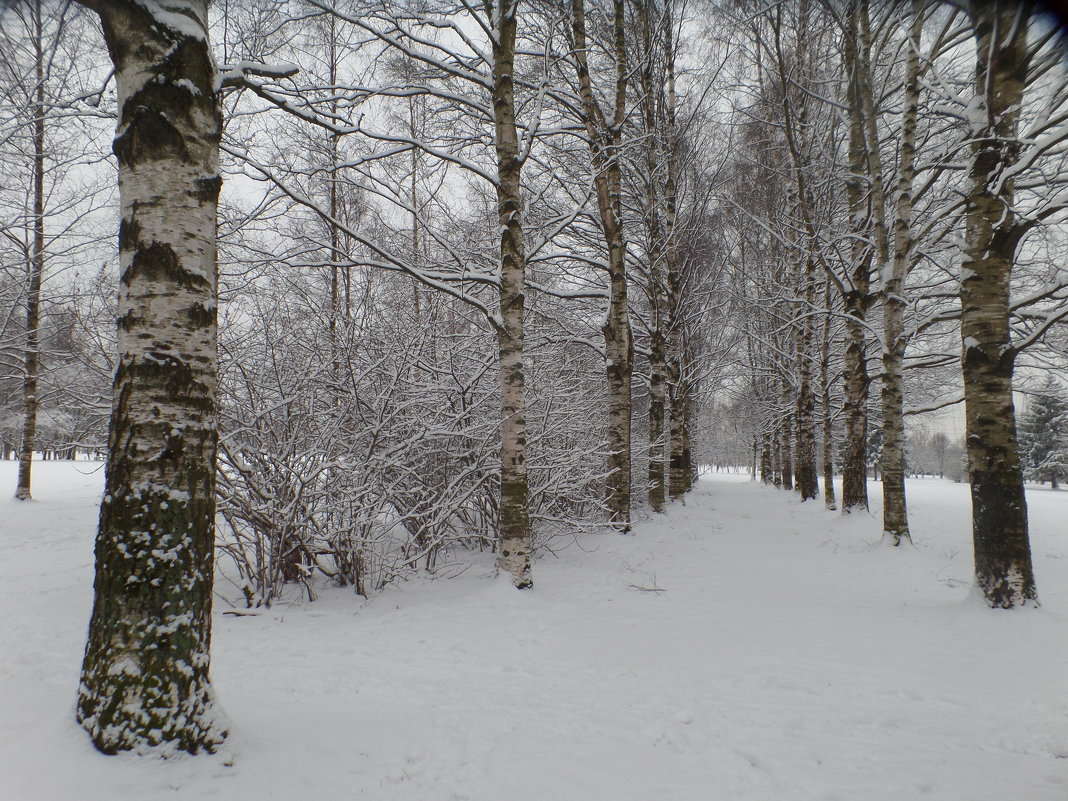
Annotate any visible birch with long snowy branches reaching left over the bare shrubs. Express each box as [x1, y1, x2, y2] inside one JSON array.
[[224, 0, 545, 588]]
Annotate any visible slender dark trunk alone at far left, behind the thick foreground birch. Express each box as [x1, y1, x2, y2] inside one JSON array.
[[15, 0, 46, 501]]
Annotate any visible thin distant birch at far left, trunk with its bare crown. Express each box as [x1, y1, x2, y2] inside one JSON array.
[[0, 0, 109, 500]]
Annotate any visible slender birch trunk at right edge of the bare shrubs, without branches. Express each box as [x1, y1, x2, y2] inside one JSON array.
[[493, 0, 534, 590]]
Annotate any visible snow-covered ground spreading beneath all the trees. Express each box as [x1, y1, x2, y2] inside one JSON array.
[[0, 462, 1068, 801]]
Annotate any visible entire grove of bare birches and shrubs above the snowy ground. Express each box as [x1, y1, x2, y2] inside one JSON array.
[[0, 0, 1068, 753]]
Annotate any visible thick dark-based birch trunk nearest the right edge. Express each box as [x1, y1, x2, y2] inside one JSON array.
[[960, 0, 1038, 609]]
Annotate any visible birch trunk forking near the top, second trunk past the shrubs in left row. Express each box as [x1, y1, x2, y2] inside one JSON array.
[[571, 0, 634, 533]]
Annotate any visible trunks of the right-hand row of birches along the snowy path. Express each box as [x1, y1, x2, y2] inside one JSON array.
[[766, 0, 1042, 608]]
